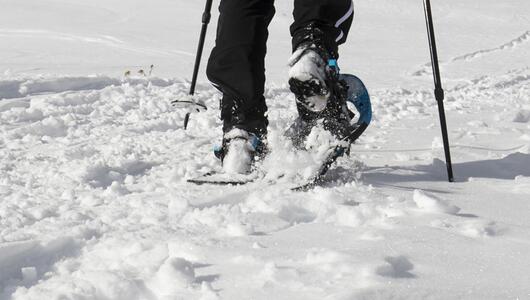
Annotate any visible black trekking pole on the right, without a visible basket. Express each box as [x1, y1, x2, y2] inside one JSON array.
[[423, 0, 454, 182]]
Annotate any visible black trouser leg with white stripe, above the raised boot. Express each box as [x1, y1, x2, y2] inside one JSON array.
[[291, 0, 353, 58]]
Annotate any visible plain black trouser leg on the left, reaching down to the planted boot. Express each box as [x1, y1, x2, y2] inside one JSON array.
[[207, 0, 275, 135]]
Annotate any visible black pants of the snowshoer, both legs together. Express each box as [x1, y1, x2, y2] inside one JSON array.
[[207, 0, 353, 135]]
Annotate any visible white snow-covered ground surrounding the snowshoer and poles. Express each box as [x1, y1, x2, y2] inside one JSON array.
[[0, 0, 530, 300]]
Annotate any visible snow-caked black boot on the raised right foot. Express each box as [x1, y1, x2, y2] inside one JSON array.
[[287, 26, 354, 147]]
